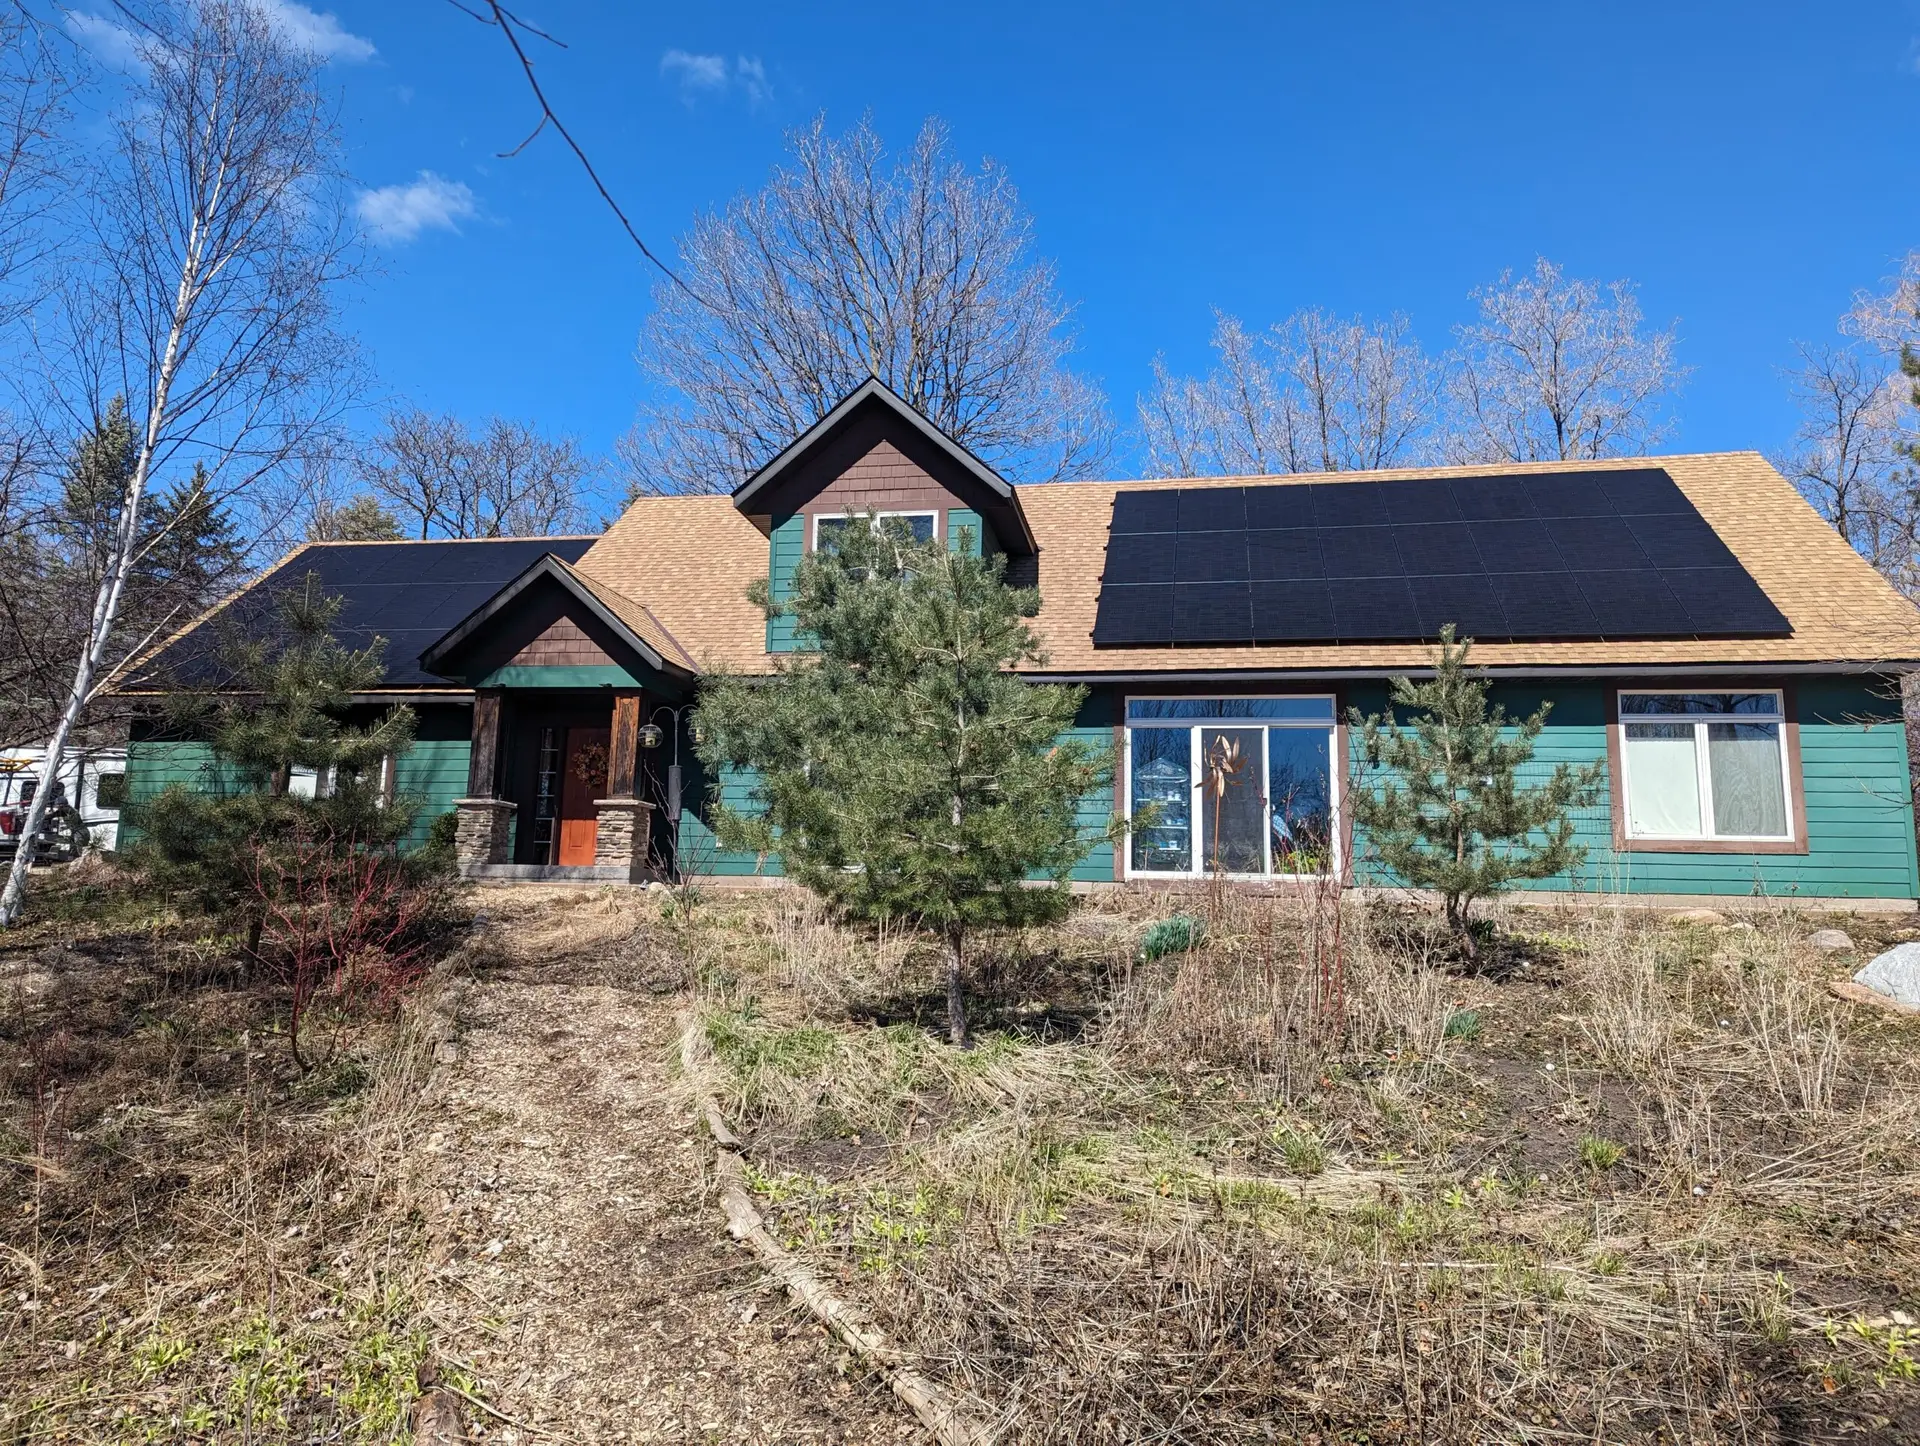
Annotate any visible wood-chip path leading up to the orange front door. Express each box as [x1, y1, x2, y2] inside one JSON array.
[[422, 893, 916, 1442]]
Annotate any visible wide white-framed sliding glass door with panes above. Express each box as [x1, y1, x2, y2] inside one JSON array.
[[1125, 697, 1336, 878]]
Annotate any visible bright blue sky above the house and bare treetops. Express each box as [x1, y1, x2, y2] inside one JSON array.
[[127, 0, 1920, 491]]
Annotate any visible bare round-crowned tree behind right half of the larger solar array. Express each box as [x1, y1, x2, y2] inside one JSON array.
[[1448, 257, 1686, 461]]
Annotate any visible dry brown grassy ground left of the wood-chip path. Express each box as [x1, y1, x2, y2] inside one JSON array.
[[0, 864, 464, 1442]]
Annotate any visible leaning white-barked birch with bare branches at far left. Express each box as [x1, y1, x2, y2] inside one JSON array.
[[0, 0, 351, 926]]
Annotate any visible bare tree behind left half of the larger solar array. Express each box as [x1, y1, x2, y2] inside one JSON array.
[[1139, 307, 1438, 476]]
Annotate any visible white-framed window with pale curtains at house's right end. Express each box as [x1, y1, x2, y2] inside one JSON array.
[[1620, 689, 1793, 843]]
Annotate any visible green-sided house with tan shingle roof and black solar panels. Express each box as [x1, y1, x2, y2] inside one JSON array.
[[129, 380, 1920, 906]]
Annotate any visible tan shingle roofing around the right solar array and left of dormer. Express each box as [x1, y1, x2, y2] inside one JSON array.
[[578, 451, 1920, 672]]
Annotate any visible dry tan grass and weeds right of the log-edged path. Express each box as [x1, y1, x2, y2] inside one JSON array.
[[675, 893, 1920, 1444]]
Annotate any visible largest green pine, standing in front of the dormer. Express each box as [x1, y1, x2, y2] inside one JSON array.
[[699, 518, 1112, 1045]]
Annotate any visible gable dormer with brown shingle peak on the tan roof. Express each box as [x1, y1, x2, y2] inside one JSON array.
[[733, 376, 1035, 653]]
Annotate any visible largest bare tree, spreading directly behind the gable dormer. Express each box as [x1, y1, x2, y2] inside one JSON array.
[[620, 119, 1110, 492]]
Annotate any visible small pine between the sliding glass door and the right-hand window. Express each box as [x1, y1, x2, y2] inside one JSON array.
[[1348, 626, 1603, 958]]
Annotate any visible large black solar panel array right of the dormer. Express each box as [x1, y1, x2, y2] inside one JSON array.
[[1092, 467, 1791, 645]]
